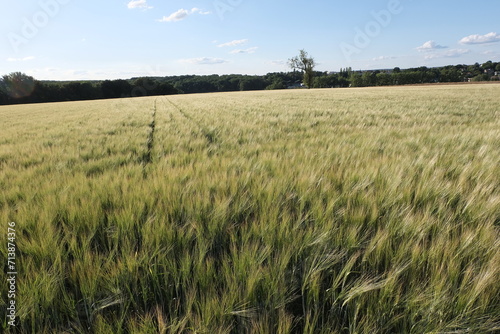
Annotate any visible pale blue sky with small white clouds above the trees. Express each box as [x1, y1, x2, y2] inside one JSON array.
[[0, 0, 500, 80]]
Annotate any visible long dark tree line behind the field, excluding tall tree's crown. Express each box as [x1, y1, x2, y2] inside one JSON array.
[[0, 61, 500, 105]]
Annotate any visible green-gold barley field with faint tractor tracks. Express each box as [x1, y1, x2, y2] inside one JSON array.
[[0, 84, 500, 334]]
